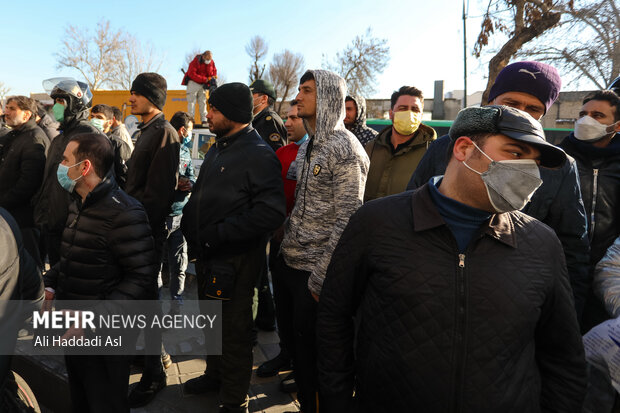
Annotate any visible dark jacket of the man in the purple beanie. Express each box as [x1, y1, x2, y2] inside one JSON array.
[[407, 135, 590, 319]]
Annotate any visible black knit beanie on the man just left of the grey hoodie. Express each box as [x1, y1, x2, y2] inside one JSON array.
[[209, 82, 254, 123]]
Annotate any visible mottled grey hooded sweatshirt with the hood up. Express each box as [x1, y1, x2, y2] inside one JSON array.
[[281, 70, 370, 294]]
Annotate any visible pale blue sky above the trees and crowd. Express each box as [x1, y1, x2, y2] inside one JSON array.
[[0, 0, 498, 98]]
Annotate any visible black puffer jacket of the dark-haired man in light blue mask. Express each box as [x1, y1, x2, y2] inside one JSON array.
[[44, 174, 159, 300]]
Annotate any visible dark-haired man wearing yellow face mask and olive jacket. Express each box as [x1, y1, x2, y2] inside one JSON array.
[[364, 86, 437, 202]]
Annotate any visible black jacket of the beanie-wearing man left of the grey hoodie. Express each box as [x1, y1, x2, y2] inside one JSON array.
[[181, 126, 286, 258]]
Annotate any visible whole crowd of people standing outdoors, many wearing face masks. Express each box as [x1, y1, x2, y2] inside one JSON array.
[[0, 58, 620, 413]]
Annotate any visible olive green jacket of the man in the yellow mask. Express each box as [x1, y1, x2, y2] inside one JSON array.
[[364, 124, 437, 202]]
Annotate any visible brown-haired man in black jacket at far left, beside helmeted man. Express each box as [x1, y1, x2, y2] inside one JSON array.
[[0, 96, 48, 268]]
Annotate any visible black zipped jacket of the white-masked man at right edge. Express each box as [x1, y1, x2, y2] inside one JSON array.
[[560, 133, 620, 333]]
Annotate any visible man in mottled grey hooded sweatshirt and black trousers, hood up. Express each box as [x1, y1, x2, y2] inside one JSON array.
[[273, 70, 368, 412]]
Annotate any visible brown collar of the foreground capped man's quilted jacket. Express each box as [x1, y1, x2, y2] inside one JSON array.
[[411, 183, 517, 248]]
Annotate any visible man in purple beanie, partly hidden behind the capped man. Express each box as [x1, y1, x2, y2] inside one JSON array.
[[407, 62, 590, 321]]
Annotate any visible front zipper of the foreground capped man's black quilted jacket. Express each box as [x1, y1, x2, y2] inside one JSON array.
[[452, 254, 465, 412]]
